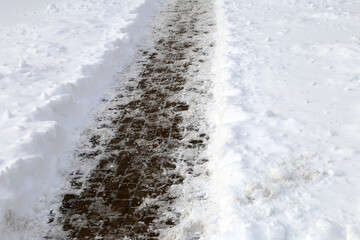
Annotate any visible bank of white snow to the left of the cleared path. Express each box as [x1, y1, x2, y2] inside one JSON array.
[[0, 0, 159, 237]]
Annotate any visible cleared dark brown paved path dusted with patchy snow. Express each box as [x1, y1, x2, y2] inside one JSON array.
[[47, 0, 215, 239]]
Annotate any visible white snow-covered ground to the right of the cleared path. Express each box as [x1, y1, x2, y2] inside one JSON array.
[[209, 0, 360, 240]]
